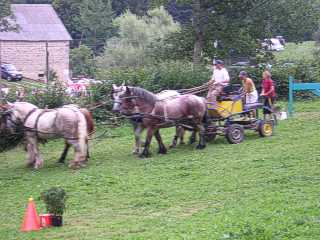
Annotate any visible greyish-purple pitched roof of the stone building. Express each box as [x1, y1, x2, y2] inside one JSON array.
[[0, 4, 72, 41]]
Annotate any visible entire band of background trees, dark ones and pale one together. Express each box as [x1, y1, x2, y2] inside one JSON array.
[[0, 0, 320, 87]]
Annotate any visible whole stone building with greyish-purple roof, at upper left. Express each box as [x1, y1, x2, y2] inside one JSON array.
[[0, 4, 72, 81]]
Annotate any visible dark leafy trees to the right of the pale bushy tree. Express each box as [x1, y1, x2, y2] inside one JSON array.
[[152, 0, 320, 64]]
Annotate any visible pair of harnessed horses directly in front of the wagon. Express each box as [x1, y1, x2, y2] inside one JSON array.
[[112, 85, 207, 157]]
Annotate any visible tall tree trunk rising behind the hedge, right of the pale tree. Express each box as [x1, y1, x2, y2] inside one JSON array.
[[192, 0, 203, 66]]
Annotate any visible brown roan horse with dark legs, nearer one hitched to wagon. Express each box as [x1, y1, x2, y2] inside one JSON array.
[[113, 86, 206, 157]]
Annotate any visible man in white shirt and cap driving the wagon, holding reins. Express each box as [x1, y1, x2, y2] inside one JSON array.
[[207, 60, 230, 106]]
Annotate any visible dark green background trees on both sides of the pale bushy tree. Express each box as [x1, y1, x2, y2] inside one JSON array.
[[8, 0, 320, 64]]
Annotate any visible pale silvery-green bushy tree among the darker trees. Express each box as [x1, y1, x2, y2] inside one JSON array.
[[99, 7, 180, 67]]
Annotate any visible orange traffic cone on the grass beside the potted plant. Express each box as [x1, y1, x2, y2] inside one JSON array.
[[21, 198, 40, 232]]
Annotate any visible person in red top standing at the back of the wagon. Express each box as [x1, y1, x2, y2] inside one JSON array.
[[261, 71, 276, 114]]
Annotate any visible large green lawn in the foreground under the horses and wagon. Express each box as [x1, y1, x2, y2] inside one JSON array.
[[0, 101, 320, 240]]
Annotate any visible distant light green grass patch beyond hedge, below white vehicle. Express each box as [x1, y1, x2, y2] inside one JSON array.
[[274, 41, 317, 62]]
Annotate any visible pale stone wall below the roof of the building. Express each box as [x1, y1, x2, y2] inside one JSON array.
[[0, 40, 69, 82]]
